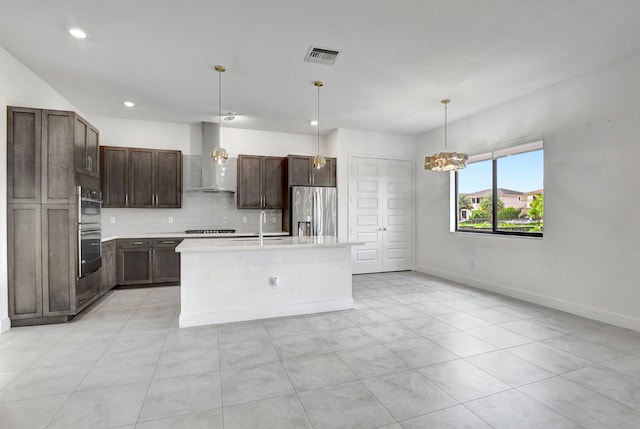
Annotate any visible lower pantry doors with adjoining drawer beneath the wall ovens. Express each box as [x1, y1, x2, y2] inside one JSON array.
[[7, 204, 102, 326]]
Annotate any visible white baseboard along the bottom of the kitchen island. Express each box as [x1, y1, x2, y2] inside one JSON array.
[[179, 298, 353, 328]]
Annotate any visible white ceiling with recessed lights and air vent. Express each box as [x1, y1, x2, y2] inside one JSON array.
[[0, 0, 640, 135]]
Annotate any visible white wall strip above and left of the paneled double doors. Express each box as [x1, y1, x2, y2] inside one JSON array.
[[327, 128, 416, 240]]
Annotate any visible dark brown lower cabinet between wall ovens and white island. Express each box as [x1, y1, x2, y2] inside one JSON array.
[[116, 238, 182, 286]]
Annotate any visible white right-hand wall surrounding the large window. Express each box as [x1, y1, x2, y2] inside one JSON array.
[[416, 51, 640, 330]]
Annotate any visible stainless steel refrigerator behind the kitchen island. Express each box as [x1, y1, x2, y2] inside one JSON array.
[[290, 186, 338, 237]]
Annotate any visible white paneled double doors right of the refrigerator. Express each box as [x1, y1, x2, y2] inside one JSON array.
[[349, 157, 413, 274]]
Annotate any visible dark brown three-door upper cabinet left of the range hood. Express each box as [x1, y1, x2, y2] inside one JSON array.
[[100, 146, 182, 208]]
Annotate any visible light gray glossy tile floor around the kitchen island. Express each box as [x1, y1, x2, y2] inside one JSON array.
[[0, 272, 640, 429]]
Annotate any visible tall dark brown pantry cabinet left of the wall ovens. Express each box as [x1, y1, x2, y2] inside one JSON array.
[[7, 107, 98, 326]]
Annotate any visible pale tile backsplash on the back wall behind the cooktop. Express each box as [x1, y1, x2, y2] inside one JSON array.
[[102, 192, 282, 237]]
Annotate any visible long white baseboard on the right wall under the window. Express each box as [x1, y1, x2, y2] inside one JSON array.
[[416, 267, 640, 332]]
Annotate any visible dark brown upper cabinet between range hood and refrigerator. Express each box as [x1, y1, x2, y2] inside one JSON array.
[[236, 155, 286, 209]]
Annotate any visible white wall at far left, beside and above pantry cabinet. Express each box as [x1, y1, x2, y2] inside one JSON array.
[[0, 48, 78, 332]]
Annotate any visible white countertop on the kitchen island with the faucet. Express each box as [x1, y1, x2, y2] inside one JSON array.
[[176, 234, 364, 253]]
